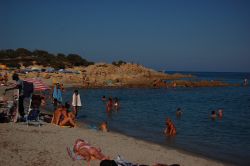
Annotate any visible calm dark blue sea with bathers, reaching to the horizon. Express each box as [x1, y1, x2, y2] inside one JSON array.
[[60, 72, 250, 165]]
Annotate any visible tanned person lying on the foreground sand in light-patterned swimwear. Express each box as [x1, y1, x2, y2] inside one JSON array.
[[67, 139, 109, 166]]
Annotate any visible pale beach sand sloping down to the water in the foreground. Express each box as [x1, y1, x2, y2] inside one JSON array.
[[0, 123, 225, 166]]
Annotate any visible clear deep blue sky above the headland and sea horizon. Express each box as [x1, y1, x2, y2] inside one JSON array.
[[0, 0, 250, 72]]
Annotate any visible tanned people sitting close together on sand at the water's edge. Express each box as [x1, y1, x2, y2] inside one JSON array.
[[51, 102, 76, 127]]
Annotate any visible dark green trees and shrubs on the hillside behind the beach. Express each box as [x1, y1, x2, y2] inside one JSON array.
[[0, 48, 94, 69]]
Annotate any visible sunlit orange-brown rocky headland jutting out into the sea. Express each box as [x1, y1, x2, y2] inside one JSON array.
[[9, 63, 238, 88]]
